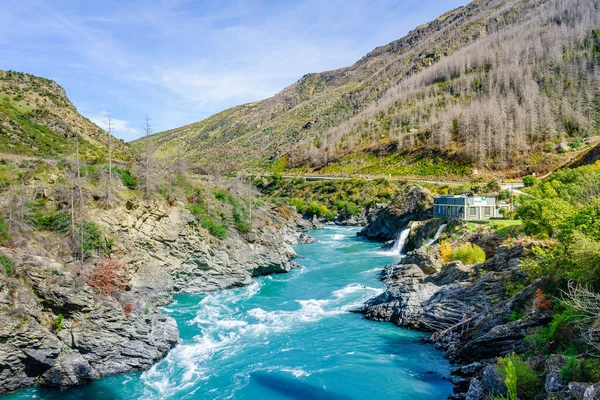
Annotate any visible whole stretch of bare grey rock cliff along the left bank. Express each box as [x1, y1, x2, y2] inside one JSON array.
[[0, 199, 312, 393]]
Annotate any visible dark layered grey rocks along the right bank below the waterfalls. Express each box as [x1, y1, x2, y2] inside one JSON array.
[[363, 224, 600, 400]]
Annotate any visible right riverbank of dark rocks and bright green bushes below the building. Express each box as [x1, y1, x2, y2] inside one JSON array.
[[356, 161, 600, 399]]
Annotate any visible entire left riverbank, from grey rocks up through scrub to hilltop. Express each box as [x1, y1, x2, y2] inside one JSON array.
[[0, 72, 312, 393]]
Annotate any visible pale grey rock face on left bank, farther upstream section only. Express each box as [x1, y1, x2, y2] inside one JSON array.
[[95, 202, 302, 305]]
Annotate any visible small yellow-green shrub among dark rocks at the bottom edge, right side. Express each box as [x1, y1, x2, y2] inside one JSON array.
[[496, 353, 543, 400]]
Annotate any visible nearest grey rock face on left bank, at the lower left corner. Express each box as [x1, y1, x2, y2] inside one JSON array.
[[0, 249, 179, 393]]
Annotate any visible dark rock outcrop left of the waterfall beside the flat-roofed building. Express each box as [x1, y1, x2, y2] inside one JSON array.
[[359, 185, 433, 241]]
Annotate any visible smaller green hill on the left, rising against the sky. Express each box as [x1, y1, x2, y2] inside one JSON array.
[[0, 71, 131, 160]]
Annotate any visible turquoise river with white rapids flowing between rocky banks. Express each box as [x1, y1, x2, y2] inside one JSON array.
[[2, 227, 452, 400]]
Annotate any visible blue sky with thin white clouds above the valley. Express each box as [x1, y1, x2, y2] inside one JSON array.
[[0, 0, 468, 140]]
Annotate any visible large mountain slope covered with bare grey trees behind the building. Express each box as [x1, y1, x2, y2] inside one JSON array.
[[144, 0, 600, 175]]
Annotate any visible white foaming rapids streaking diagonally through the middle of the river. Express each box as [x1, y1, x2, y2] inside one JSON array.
[[142, 280, 382, 399]]
